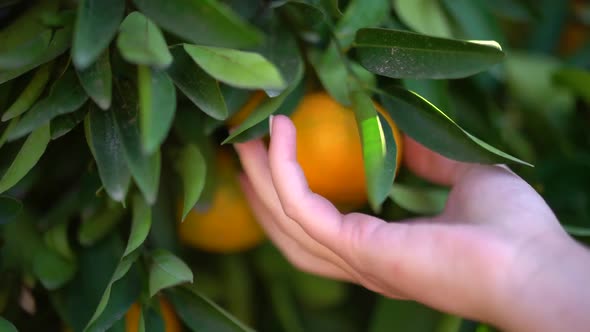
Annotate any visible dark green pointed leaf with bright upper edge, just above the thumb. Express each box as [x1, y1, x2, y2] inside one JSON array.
[[379, 87, 531, 166]]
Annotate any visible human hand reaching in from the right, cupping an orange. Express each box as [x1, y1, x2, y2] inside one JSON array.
[[236, 116, 590, 331]]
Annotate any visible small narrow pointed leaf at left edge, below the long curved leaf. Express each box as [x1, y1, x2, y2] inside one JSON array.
[[2, 63, 52, 121]]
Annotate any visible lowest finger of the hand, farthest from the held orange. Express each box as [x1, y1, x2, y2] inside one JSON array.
[[240, 176, 354, 282]]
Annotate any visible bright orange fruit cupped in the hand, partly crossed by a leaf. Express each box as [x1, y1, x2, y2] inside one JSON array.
[[291, 92, 402, 208]]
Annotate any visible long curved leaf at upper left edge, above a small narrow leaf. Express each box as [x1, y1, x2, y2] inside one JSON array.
[[0, 21, 72, 84]]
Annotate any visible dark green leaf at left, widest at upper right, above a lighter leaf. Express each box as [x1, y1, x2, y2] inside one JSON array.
[[8, 70, 88, 140]]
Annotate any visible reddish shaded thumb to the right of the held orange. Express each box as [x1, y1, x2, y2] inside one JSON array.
[[403, 136, 472, 186]]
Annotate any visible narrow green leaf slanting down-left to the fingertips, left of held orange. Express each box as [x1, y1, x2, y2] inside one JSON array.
[[222, 60, 303, 144]]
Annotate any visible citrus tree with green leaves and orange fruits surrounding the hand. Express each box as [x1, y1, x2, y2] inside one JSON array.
[[0, 0, 590, 332]]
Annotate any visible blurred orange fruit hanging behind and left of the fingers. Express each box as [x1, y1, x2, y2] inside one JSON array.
[[178, 154, 264, 253]]
